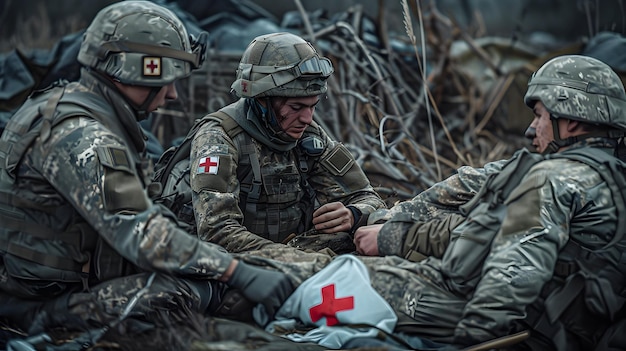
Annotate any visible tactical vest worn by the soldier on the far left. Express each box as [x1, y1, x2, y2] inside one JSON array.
[[0, 83, 139, 298]]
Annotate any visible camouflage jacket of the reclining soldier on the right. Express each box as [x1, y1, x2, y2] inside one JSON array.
[[414, 138, 626, 341]]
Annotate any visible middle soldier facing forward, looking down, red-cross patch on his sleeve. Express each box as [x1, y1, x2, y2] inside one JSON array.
[[190, 33, 385, 252]]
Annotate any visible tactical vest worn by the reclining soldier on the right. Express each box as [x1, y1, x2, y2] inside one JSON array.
[[461, 148, 626, 351]]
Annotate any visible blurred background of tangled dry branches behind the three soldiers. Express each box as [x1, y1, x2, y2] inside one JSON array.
[[0, 0, 626, 204]]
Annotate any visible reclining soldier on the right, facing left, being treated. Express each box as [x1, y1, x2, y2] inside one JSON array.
[[243, 55, 626, 350]]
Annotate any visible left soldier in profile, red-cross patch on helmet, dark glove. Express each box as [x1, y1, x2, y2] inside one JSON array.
[[0, 1, 293, 338]]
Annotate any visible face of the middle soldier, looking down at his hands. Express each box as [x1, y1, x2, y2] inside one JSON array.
[[274, 96, 319, 139]]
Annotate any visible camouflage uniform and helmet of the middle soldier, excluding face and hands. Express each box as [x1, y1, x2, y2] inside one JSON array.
[[190, 33, 385, 252]]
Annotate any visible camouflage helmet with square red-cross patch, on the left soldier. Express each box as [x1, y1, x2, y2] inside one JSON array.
[[78, 1, 206, 87]]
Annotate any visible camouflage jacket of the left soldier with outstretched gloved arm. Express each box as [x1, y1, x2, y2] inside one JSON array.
[[0, 71, 232, 298]]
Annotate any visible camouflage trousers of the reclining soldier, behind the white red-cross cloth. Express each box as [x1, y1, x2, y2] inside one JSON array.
[[236, 246, 467, 343]]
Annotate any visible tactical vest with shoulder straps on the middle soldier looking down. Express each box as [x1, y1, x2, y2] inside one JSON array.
[[154, 111, 316, 242]]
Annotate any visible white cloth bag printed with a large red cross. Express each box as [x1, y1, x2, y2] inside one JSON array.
[[257, 255, 397, 348]]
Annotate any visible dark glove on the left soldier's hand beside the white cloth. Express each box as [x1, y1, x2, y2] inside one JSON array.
[[228, 261, 294, 319]]
